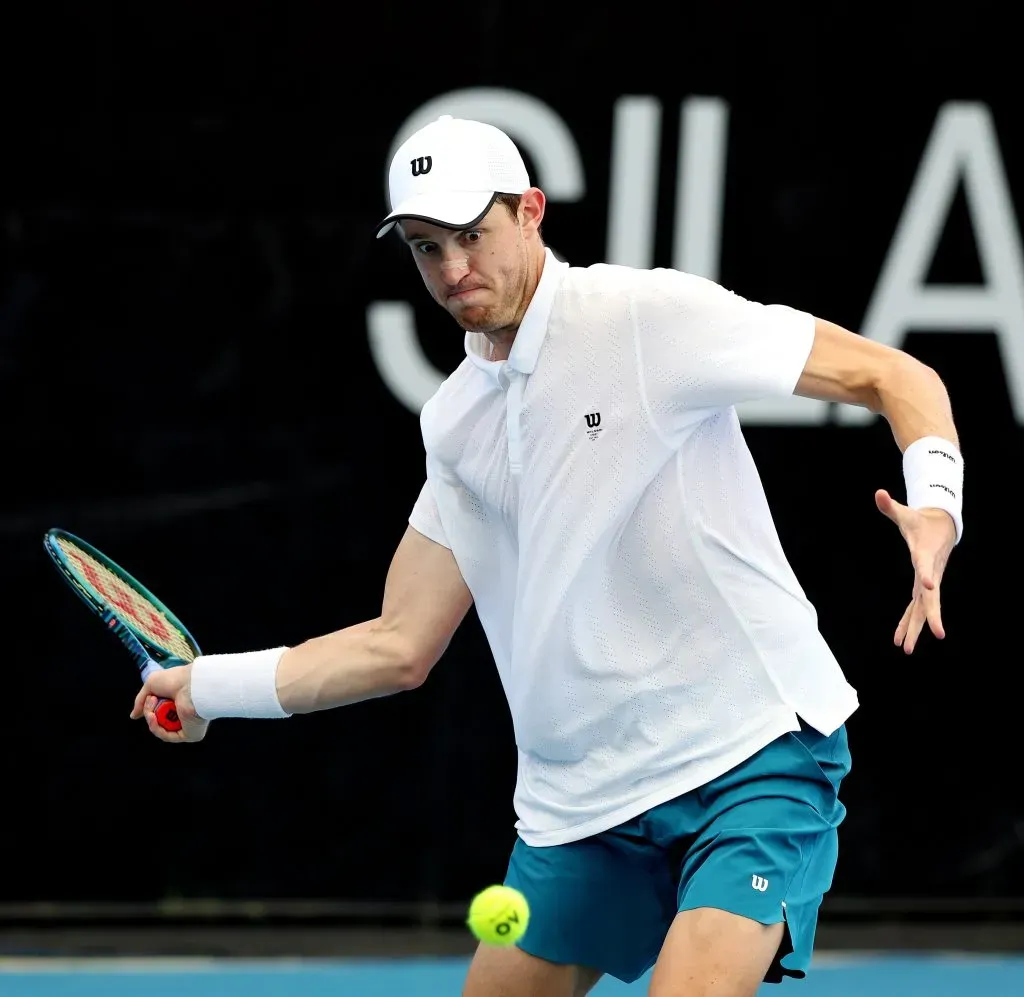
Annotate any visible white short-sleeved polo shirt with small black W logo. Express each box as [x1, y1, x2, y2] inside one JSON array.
[[410, 245, 857, 846]]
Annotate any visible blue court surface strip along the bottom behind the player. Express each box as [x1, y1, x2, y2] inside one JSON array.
[[0, 953, 1024, 997]]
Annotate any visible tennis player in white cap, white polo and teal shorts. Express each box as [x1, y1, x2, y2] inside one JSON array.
[[133, 118, 963, 997]]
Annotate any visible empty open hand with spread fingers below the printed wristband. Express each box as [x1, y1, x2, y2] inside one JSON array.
[[874, 488, 956, 654]]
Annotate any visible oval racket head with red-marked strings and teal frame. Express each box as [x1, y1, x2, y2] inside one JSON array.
[[43, 527, 201, 663]]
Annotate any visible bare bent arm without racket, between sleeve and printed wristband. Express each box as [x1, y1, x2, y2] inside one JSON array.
[[795, 318, 959, 450]]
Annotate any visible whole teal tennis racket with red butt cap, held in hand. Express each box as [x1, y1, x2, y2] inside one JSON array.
[[43, 528, 201, 731]]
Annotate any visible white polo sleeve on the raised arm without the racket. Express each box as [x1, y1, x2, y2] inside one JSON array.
[[632, 270, 814, 431]]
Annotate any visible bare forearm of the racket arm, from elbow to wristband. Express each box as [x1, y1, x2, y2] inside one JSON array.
[[278, 619, 423, 713]]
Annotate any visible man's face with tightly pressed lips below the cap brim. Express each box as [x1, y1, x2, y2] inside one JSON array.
[[400, 204, 528, 333]]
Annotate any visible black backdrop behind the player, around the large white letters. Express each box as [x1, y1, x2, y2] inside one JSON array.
[[0, 0, 1024, 921]]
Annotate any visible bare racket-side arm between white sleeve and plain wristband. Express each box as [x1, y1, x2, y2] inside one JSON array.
[[278, 527, 472, 713]]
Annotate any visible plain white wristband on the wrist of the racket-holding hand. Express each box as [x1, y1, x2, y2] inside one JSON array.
[[191, 647, 290, 720]]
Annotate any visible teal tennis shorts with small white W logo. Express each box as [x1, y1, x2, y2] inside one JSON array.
[[505, 726, 850, 983]]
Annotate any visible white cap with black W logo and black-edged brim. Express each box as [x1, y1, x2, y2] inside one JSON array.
[[377, 115, 530, 239]]
